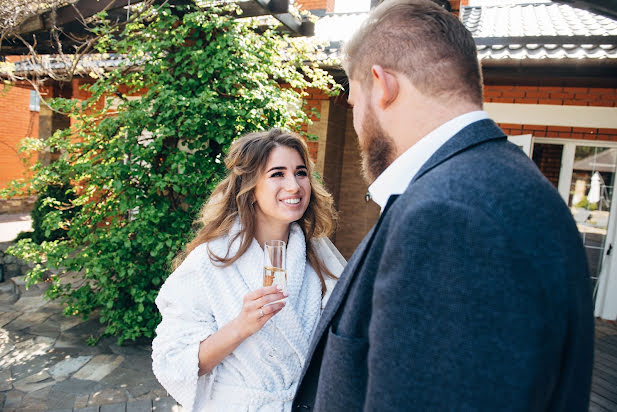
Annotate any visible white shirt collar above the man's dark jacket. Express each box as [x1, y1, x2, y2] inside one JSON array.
[[368, 110, 488, 211]]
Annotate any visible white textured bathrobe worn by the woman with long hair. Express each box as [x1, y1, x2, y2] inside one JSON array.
[[152, 223, 344, 412]]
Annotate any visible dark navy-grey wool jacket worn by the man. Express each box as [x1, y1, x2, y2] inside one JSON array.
[[294, 120, 593, 412]]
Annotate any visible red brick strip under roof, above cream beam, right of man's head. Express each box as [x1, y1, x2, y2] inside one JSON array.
[[484, 85, 617, 107]]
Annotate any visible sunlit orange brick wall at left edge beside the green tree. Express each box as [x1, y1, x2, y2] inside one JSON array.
[[0, 84, 39, 189]]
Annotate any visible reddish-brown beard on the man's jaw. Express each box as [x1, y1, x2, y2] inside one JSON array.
[[358, 106, 396, 185]]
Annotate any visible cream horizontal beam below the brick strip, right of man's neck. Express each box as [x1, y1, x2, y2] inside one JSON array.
[[484, 103, 617, 129]]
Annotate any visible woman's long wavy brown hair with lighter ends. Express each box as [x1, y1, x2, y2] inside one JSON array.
[[173, 129, 337, 295]]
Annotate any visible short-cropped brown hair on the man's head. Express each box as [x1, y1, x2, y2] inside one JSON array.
[[343, 0, 482, 105]]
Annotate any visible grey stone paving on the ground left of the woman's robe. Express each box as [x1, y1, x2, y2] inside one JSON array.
[[0, 277, 181, 412]]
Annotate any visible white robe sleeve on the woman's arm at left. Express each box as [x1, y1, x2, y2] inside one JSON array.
[[152, 251, 217, 410]]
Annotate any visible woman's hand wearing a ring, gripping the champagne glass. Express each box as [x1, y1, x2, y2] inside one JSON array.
[[234, 286, 288, 339]]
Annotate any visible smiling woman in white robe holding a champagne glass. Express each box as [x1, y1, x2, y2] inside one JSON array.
[[152, 129, 344, 412]]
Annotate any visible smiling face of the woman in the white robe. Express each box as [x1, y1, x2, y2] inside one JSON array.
[[253, 146, 311, 229]]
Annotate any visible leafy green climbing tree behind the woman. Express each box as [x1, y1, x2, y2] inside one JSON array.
[[5, 1, 336, 343]]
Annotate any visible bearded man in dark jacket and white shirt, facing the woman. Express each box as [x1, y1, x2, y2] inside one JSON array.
[[294, 0, 593, 412]]
